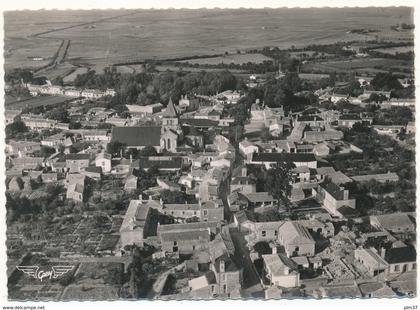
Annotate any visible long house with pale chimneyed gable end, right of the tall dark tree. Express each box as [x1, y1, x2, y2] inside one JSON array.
[[312, 182, 356, 217]]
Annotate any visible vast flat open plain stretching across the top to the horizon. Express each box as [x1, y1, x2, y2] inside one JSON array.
[[5, 8, 412, 71]]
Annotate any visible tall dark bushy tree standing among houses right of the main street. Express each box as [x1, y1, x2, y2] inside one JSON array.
[[265, 163, 293, 201]]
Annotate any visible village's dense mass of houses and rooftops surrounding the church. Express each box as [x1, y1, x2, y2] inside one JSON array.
[[6, 81, 416, 298]]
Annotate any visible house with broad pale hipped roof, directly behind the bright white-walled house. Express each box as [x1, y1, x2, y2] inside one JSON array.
[[278, 221, 315, 257]]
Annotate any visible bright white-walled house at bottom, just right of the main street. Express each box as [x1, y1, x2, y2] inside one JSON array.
[[262, 254, 300, 288]]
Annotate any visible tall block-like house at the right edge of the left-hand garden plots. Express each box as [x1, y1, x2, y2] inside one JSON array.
[[120, 200, 153, 248]]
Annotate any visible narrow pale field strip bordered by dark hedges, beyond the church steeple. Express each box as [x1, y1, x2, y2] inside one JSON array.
[[179, 53, 272, 65]]
